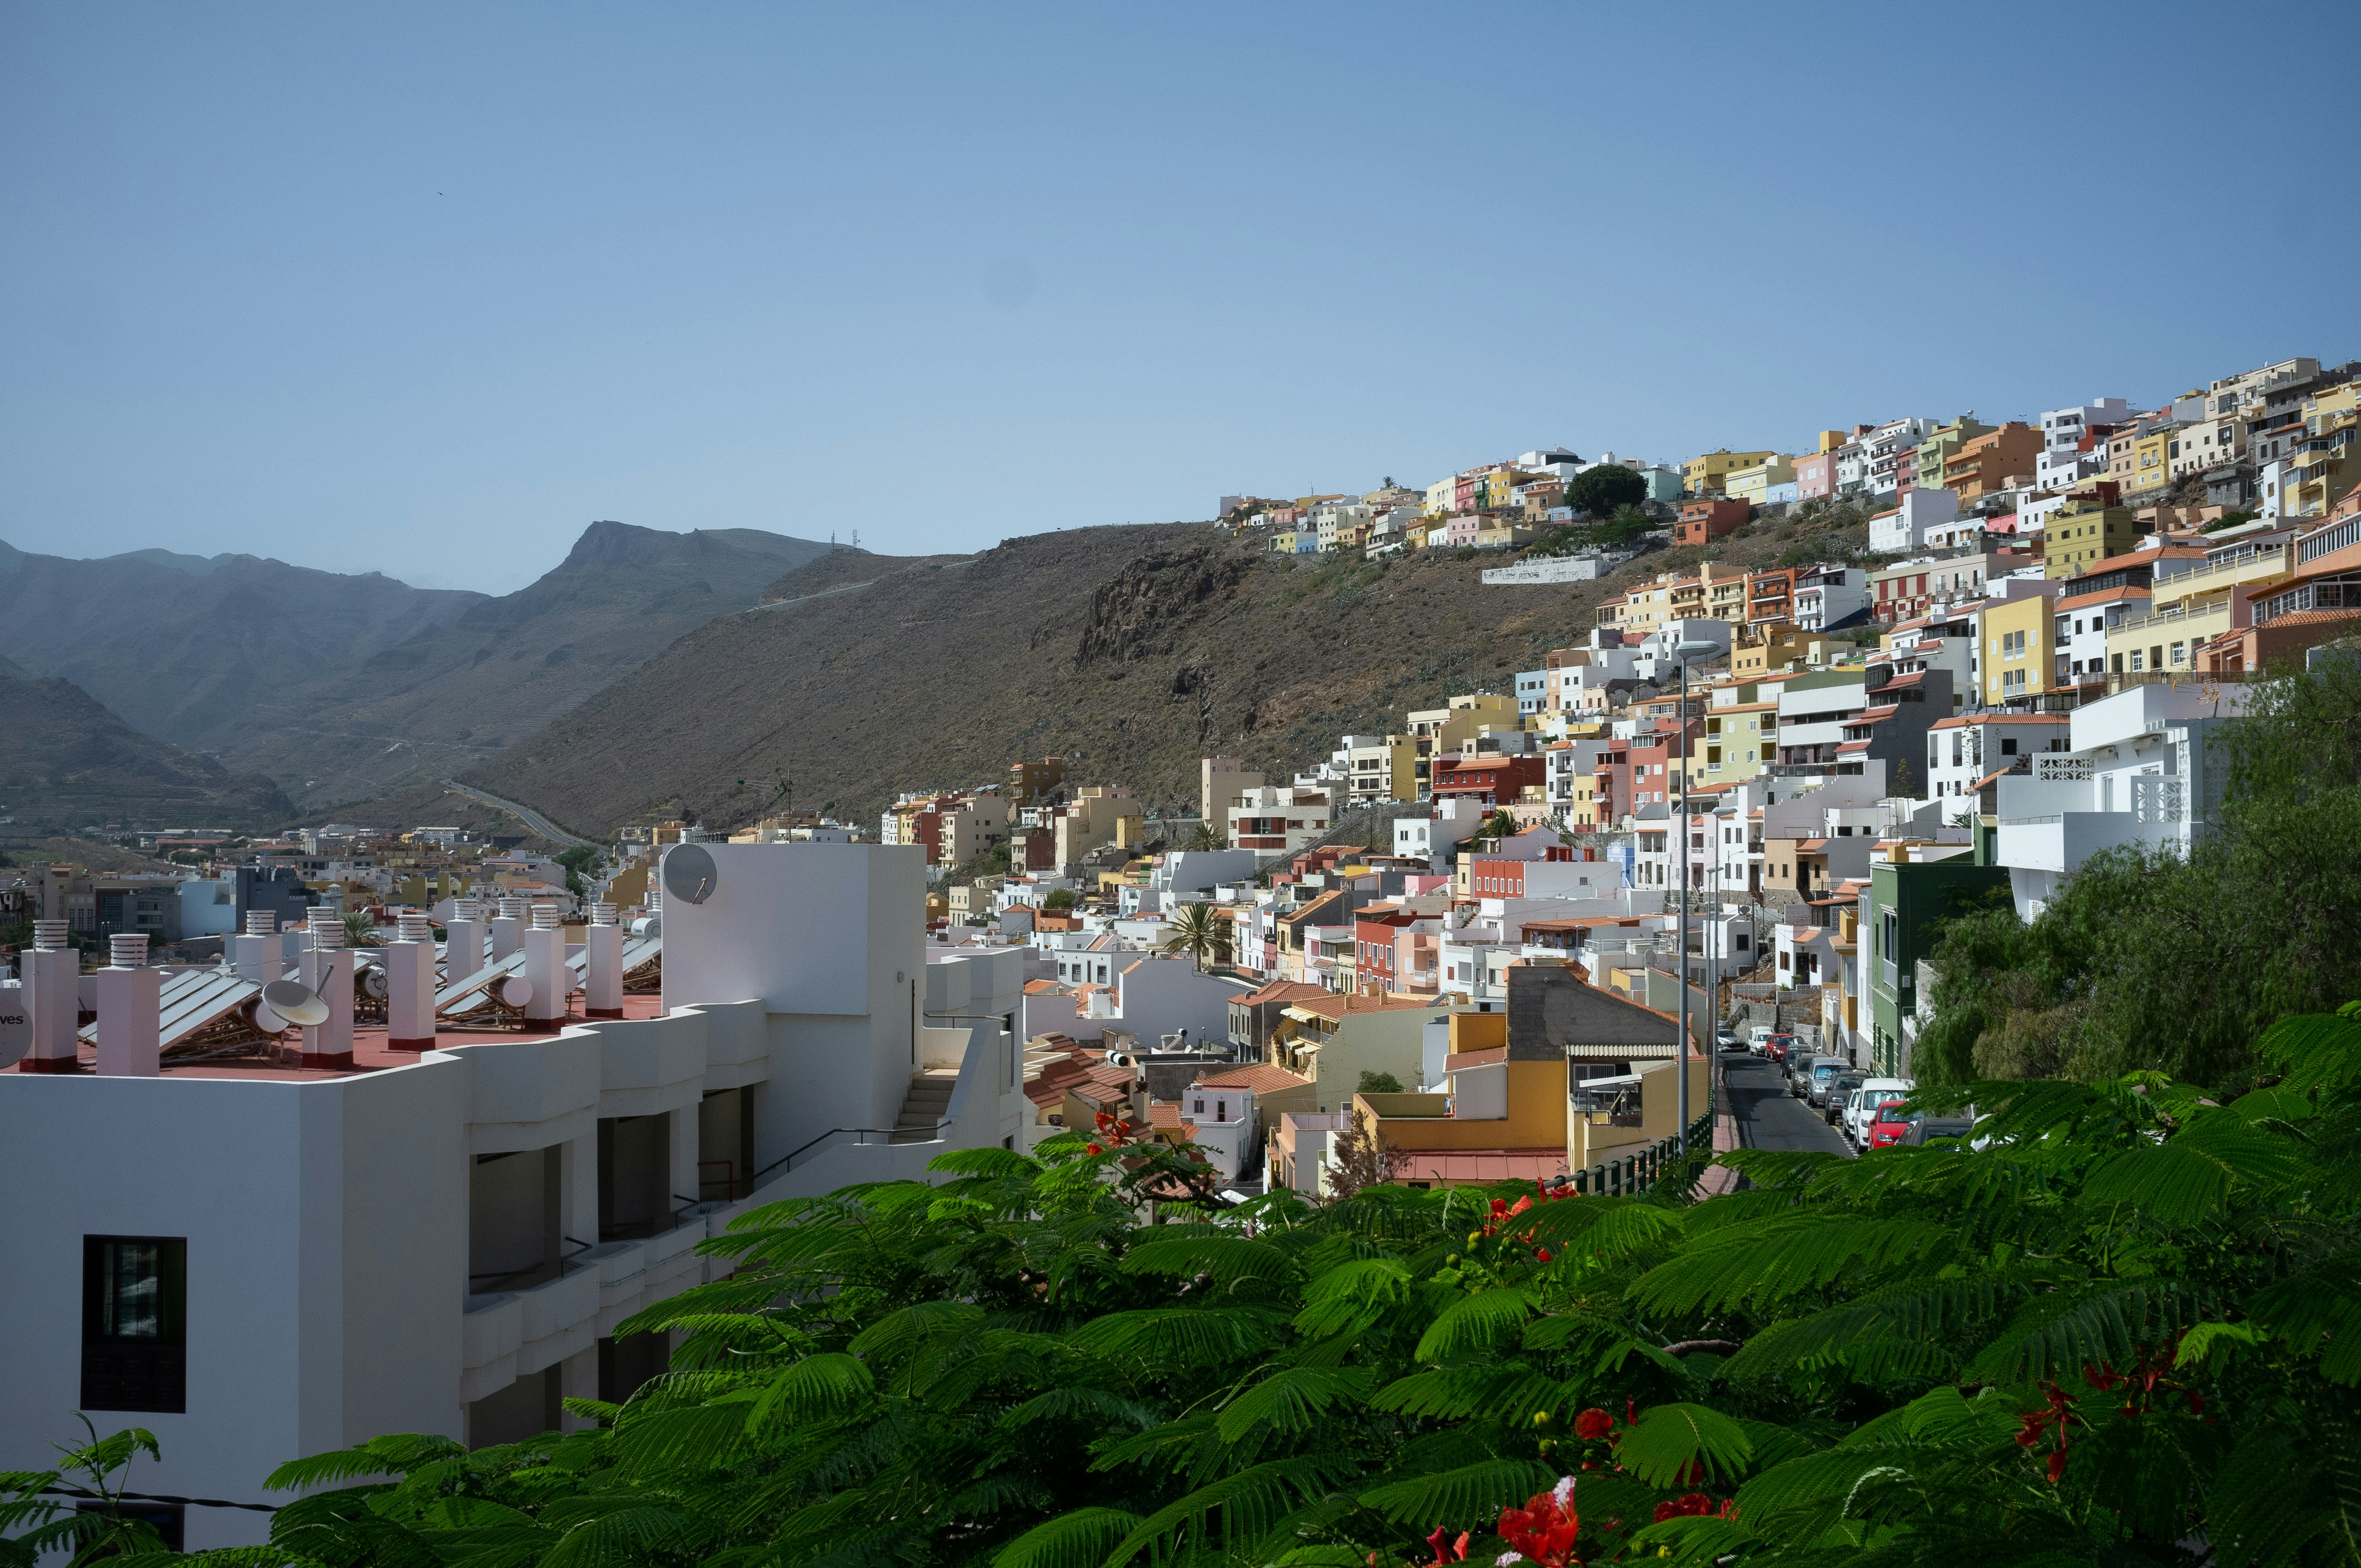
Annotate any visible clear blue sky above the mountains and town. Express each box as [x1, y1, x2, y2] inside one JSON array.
[[0, 0, 2361, 590]]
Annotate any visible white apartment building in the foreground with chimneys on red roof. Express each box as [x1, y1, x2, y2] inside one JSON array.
[[0, 843, 1030, 1549]]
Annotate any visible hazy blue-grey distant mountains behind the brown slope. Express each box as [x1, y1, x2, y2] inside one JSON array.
[[0, 522, 829, 812]]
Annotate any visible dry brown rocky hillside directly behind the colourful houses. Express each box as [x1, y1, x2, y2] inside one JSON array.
[[467, 524, 1686, 834]]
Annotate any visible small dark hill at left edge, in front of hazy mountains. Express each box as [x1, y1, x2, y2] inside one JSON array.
[[0, 666, 295, 836]]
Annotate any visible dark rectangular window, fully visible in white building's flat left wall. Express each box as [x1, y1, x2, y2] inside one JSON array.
[[83, 1235, 189, 1414]]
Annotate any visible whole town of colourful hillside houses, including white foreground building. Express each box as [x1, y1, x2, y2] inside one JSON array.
[[0, 347, 2361, 1539]]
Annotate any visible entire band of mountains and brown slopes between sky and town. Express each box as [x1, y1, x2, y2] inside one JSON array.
[[0, 522, 1643, 834]]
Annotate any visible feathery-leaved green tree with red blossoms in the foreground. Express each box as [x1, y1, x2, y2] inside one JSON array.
[[106, 1008, 2361, 1568]]
